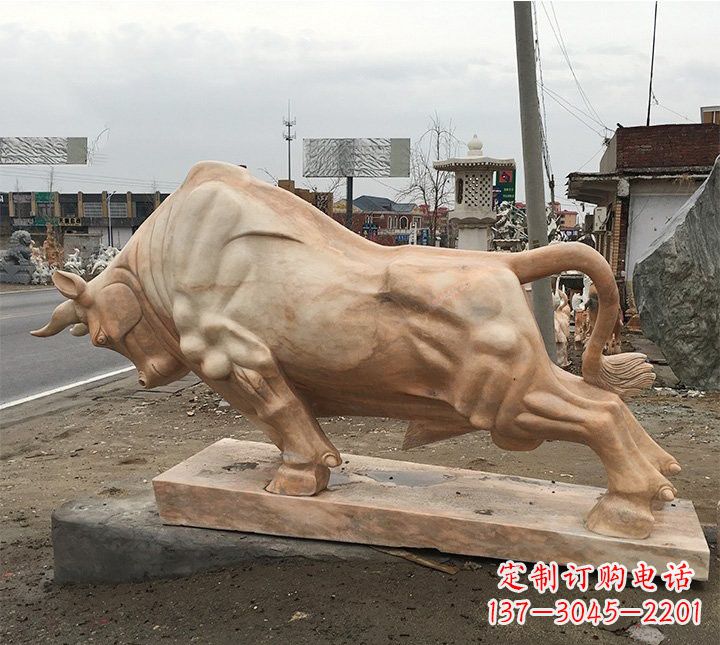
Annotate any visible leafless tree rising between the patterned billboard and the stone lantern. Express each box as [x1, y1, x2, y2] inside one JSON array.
[[398, 112, 458, 245]]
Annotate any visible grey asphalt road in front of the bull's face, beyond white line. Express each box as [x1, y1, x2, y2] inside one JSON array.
[[0, 289, 131, 405]]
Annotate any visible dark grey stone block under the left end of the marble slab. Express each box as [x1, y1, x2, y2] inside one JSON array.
[[52, 493, 397, 584]]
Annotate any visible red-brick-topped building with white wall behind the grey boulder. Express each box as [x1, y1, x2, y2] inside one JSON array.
[[567, 123, 720, 284]]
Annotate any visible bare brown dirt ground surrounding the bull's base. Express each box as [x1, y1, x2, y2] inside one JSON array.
[[0, 372, 720, 645]]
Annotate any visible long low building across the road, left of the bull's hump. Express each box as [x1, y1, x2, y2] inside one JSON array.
[[0, 191, 169, 248]]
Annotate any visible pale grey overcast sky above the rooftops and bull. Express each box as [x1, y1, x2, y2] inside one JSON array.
[[0, 0, 720, 206]]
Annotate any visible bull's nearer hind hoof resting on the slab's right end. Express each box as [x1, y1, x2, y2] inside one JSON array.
[[585, 493, 655, 539]]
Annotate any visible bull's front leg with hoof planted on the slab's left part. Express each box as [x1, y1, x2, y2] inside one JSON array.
[[181, 319, 341, 495]]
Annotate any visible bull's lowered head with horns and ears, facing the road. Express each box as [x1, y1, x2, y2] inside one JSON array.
[[30, 268, 189, 388]]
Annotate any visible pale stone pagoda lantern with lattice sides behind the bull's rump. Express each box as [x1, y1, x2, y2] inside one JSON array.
[[433, 135, 515, 251]]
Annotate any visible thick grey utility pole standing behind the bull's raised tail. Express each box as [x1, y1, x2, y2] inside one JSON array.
[[513, 2, 556, 361]]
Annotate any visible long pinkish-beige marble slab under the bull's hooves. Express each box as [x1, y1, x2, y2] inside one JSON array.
[[153, 439, 710, 580]]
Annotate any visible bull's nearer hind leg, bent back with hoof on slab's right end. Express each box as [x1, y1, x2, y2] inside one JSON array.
[[493, 379, 675, 538]]
